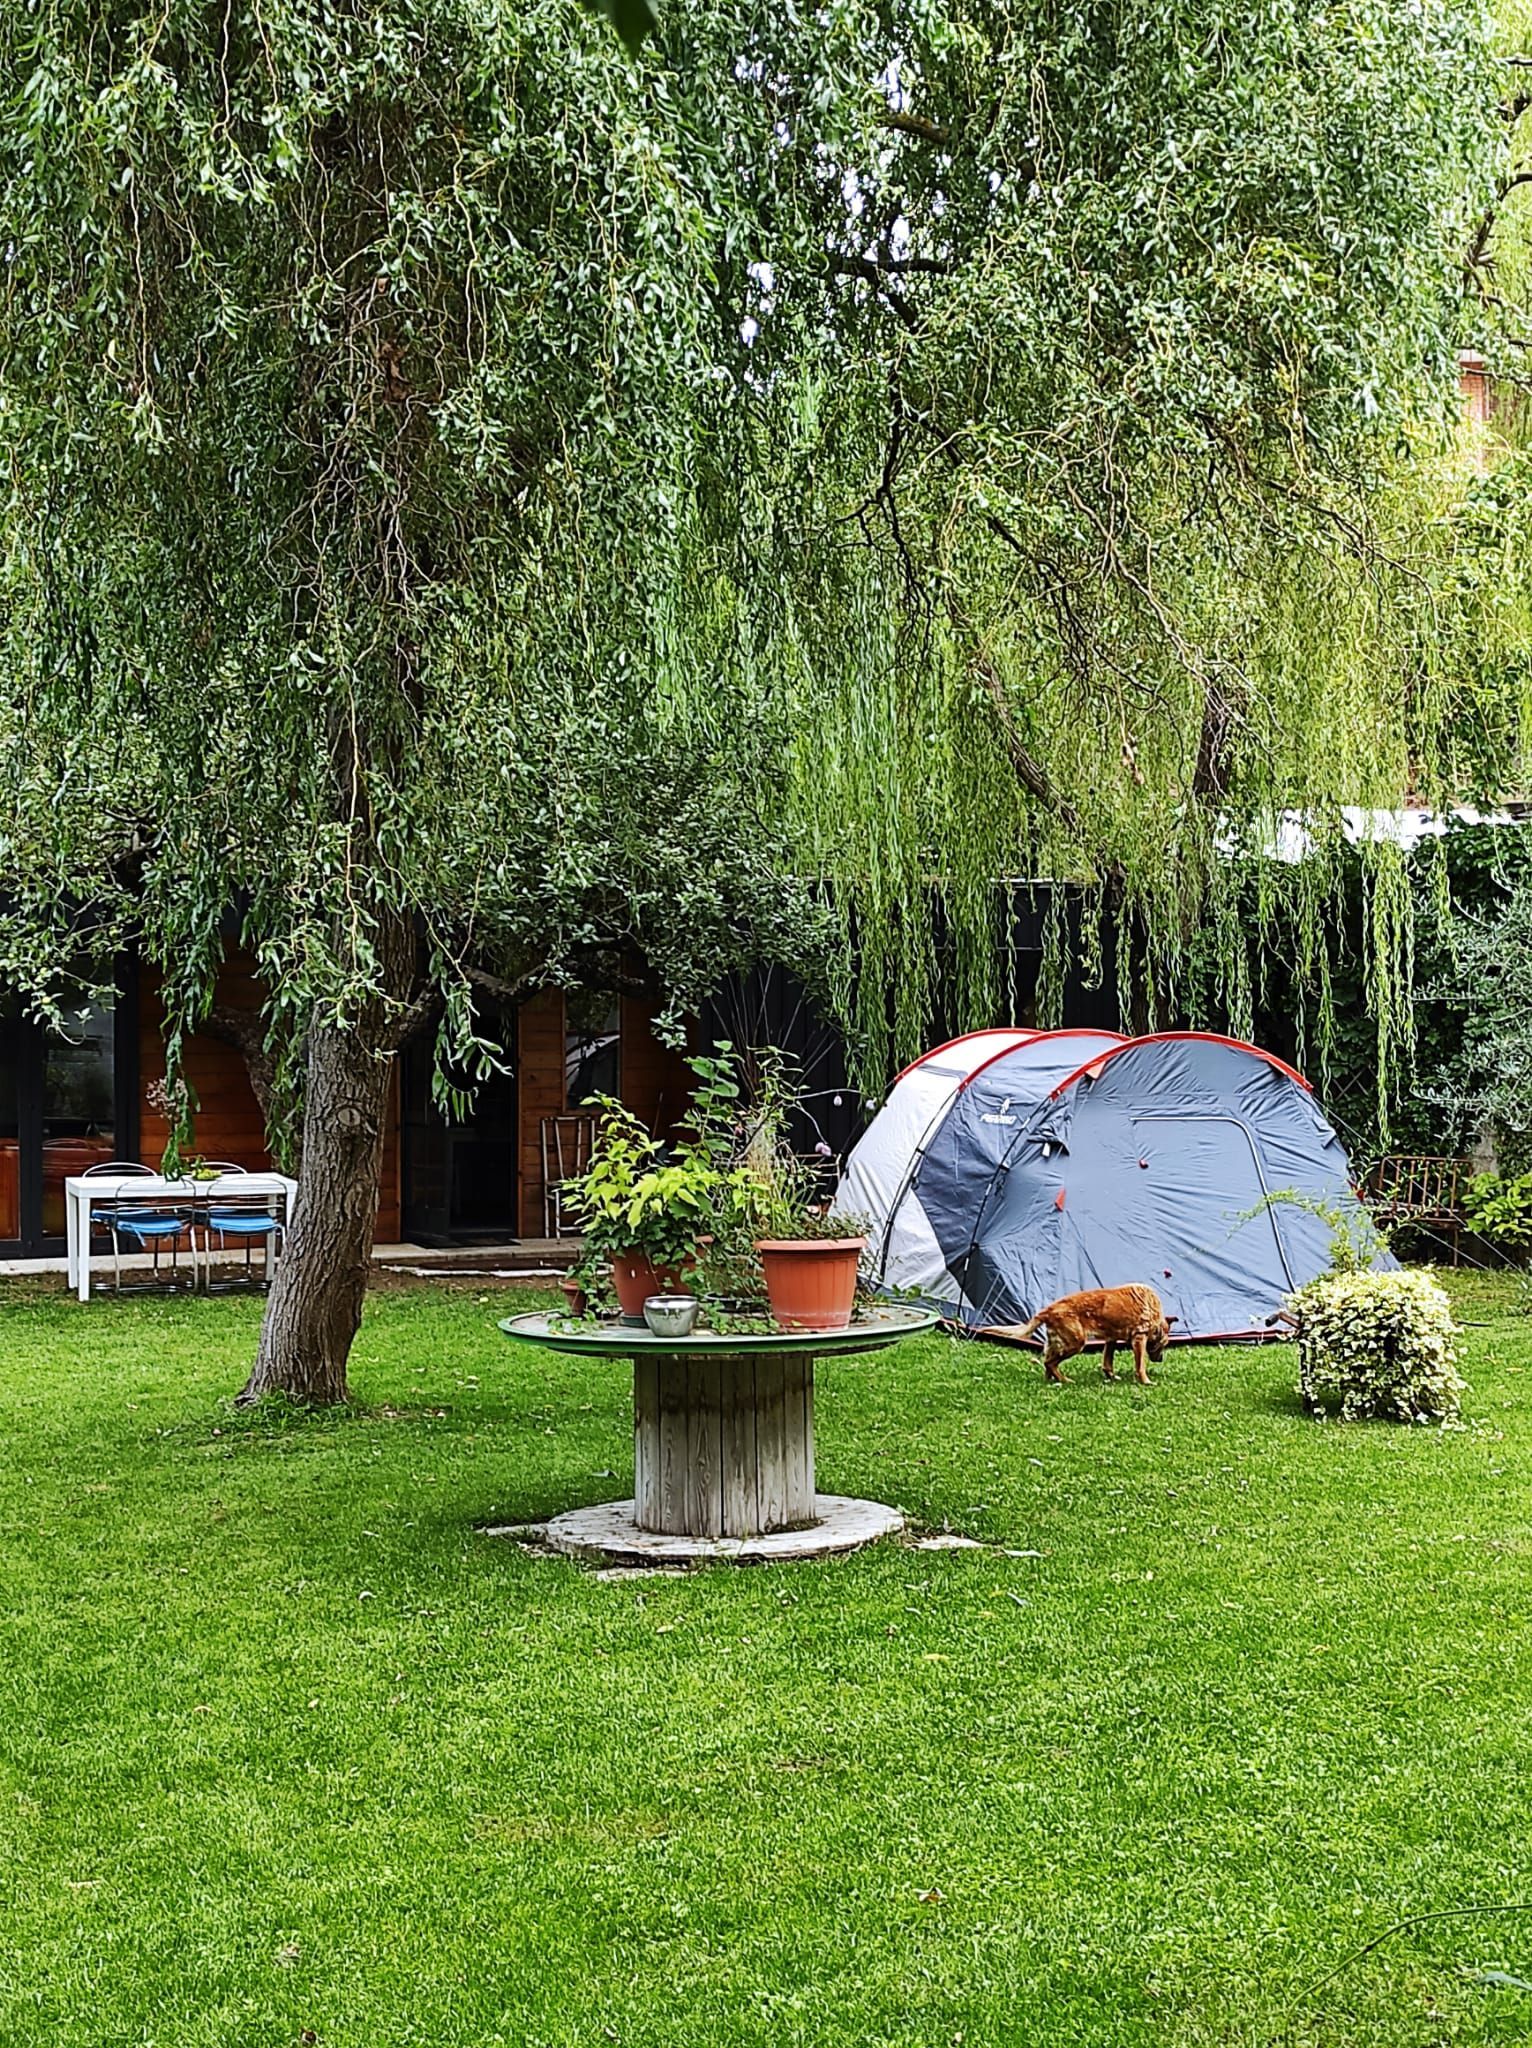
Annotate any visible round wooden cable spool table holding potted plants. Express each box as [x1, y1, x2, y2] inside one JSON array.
[[500, 1307, 936, 1563]]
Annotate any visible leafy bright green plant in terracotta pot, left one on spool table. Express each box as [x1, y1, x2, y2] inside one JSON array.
[[569, 1096, 719, 1323]]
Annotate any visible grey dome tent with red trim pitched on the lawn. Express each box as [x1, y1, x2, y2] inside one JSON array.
[[836, 1030, 1393, 1339]]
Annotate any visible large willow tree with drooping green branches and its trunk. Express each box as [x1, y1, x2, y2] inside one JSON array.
[[0, 0, 1499, 1395]]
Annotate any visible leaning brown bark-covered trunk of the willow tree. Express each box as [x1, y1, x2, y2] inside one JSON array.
[[240, 920, 414, 1405]]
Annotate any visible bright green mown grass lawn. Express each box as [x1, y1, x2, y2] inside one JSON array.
[[0, 1282, 1532, 2048]]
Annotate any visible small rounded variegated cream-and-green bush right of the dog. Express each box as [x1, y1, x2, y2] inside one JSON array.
[[1288, 1272, 1462, 1421]]
